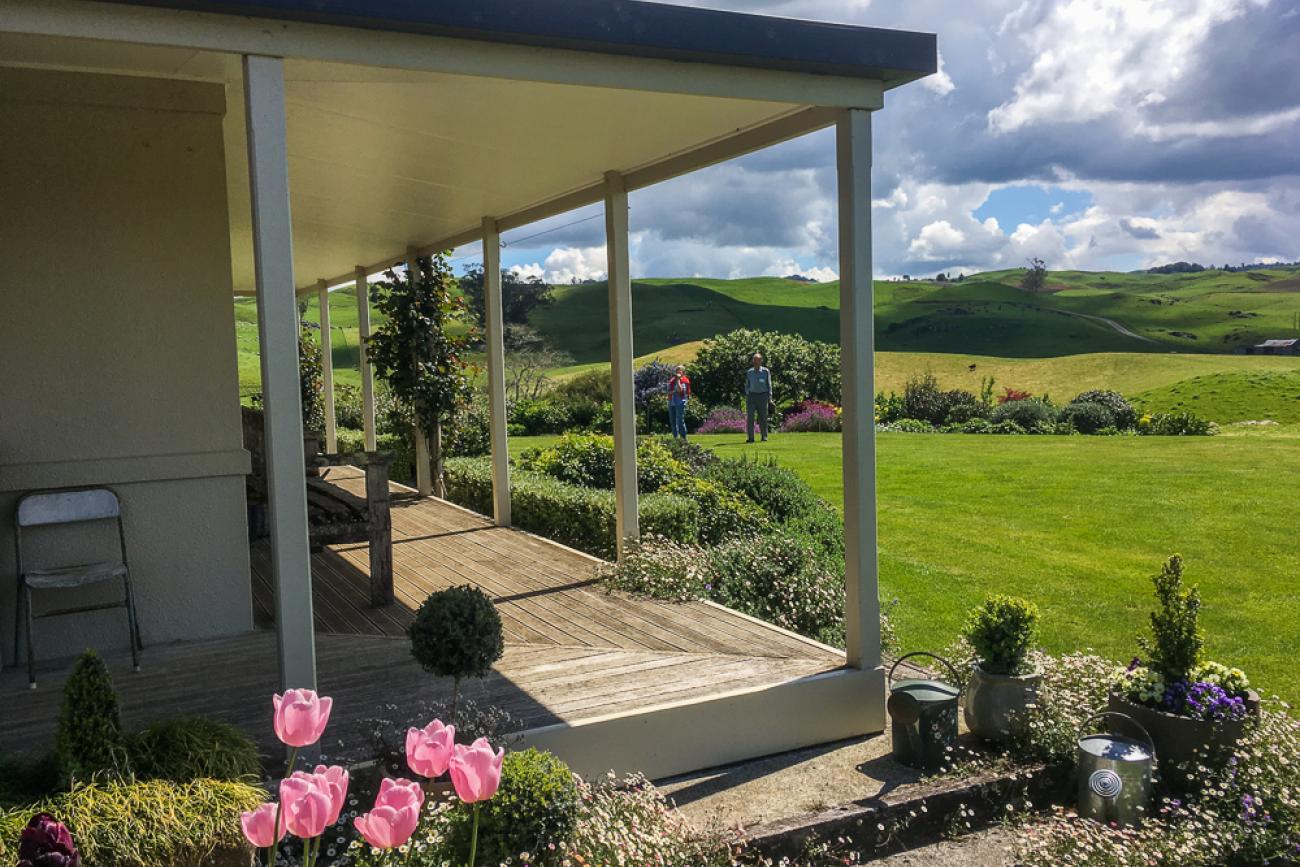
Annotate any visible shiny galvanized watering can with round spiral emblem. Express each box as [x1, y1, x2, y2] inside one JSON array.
[[1079, 711, 1156, 825]]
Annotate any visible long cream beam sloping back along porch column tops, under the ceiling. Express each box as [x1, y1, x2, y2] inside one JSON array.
[[303, 107, 840, 291]]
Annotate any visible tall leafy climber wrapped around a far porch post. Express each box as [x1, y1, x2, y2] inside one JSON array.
[[367, 253, 477, 497]]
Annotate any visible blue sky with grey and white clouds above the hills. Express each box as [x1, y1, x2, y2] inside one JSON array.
[[456, 0, 1300, 282]]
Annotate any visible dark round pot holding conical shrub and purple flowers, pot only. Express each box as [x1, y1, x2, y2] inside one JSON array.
[[1106, 690, 1260, 792]]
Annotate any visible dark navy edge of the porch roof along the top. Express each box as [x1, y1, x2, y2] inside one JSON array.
[[100, 0, 937, 86]]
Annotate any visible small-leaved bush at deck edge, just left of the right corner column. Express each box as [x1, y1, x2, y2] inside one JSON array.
[[706, 529, 844, 646]]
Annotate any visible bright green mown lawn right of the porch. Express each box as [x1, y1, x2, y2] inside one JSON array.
[[511, 426, 1300, 701]]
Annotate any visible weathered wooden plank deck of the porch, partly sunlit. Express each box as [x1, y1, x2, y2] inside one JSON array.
[[0, 468, 844, 760]]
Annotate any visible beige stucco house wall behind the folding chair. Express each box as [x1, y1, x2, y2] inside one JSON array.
[[0, 69, 252, 663]]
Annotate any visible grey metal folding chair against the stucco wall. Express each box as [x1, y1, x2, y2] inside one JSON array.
[[13, 487, 144, 689]]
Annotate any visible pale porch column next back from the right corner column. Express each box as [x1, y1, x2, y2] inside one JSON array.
[[605, 172, 641, 558]]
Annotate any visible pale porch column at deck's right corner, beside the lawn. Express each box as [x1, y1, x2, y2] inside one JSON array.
[[836, 108, 884, 675]]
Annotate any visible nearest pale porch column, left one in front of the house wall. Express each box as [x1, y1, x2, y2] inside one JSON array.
[[243, 55, 316, 689]]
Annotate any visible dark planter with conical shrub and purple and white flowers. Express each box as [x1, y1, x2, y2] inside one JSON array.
[[1109, 554, 1260, 788]]
